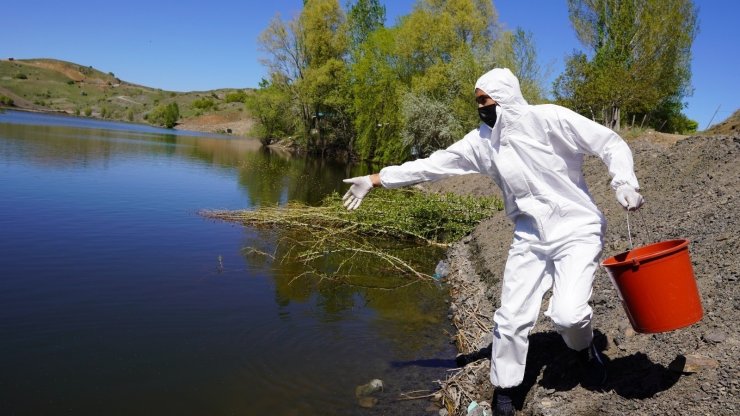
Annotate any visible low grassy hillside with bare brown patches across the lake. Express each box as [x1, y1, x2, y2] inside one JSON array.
[[0, 58, 252, 134]]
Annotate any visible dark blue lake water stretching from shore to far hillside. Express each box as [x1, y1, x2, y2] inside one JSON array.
[[0, 111, 455, 415]]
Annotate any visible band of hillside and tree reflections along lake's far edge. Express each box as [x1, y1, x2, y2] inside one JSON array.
[[0, 112, 358, 206]]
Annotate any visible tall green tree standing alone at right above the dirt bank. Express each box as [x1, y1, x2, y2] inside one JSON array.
[[554, 0, 697, 130]]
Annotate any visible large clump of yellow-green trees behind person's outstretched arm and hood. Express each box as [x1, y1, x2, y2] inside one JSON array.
[[256, 0, 544, 163]]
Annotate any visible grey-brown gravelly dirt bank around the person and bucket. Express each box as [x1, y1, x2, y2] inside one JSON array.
[[427, 135, 740, 415]]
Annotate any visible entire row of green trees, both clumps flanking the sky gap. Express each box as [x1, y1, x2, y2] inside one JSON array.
[[246, 0, 696, 163]]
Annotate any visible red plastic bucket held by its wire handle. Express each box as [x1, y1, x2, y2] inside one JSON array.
[[601, 240, 703, 333]]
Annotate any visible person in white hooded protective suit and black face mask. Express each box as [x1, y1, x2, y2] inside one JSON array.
[[344, 68, 643, 414]]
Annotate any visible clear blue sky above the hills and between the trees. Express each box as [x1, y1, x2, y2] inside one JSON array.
[[0, 0, 740, 129]]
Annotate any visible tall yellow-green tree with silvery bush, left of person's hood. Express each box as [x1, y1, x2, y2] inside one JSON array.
[[396, 0, 499, 157]]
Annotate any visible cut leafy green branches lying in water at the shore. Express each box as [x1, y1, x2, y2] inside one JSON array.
[[200, 189, 503, 284]]
